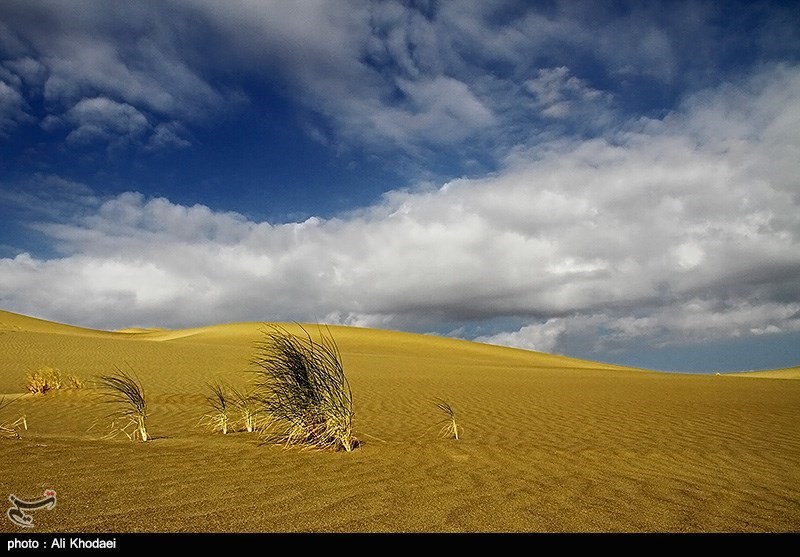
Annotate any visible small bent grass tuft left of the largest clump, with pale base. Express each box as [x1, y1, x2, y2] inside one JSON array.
[[97, 366, 151, 441]]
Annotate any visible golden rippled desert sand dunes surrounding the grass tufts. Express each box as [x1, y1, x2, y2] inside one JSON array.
[[0, 311, 800, 532]]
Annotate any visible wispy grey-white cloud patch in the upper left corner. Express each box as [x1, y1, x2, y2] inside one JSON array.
[[0, 0, 234, 149]]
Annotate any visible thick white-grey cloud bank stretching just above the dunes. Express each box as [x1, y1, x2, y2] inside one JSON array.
[[0, 66, 800, 351]]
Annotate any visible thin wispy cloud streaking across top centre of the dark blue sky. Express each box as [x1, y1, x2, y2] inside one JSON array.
[[153, 0, 675, 156]]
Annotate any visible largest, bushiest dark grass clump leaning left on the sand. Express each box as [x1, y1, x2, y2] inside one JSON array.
[[251, 325, 358, 451]]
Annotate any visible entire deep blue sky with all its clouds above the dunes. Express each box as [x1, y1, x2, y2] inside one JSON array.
[[0, 0, 800, 373]]
